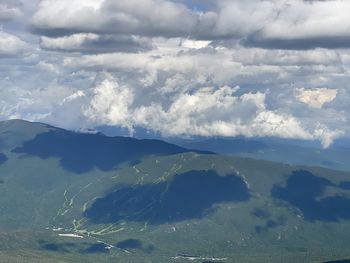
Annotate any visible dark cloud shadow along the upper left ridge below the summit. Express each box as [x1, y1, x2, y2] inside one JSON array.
[[13, 129, 208, 173]]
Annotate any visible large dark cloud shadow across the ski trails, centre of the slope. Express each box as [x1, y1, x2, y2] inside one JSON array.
[[85, 170, 250, 224]]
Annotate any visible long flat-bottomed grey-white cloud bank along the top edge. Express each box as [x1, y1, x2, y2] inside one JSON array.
[[32, 0, 350, 49]]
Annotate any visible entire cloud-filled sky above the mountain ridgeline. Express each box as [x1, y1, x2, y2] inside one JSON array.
[[0, 0, 350, 147]]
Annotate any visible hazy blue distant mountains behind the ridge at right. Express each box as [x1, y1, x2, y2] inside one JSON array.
[[174, 138, 350, 171]]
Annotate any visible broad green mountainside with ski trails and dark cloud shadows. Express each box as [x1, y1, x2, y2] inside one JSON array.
[[0, 121, 350, 262]]
